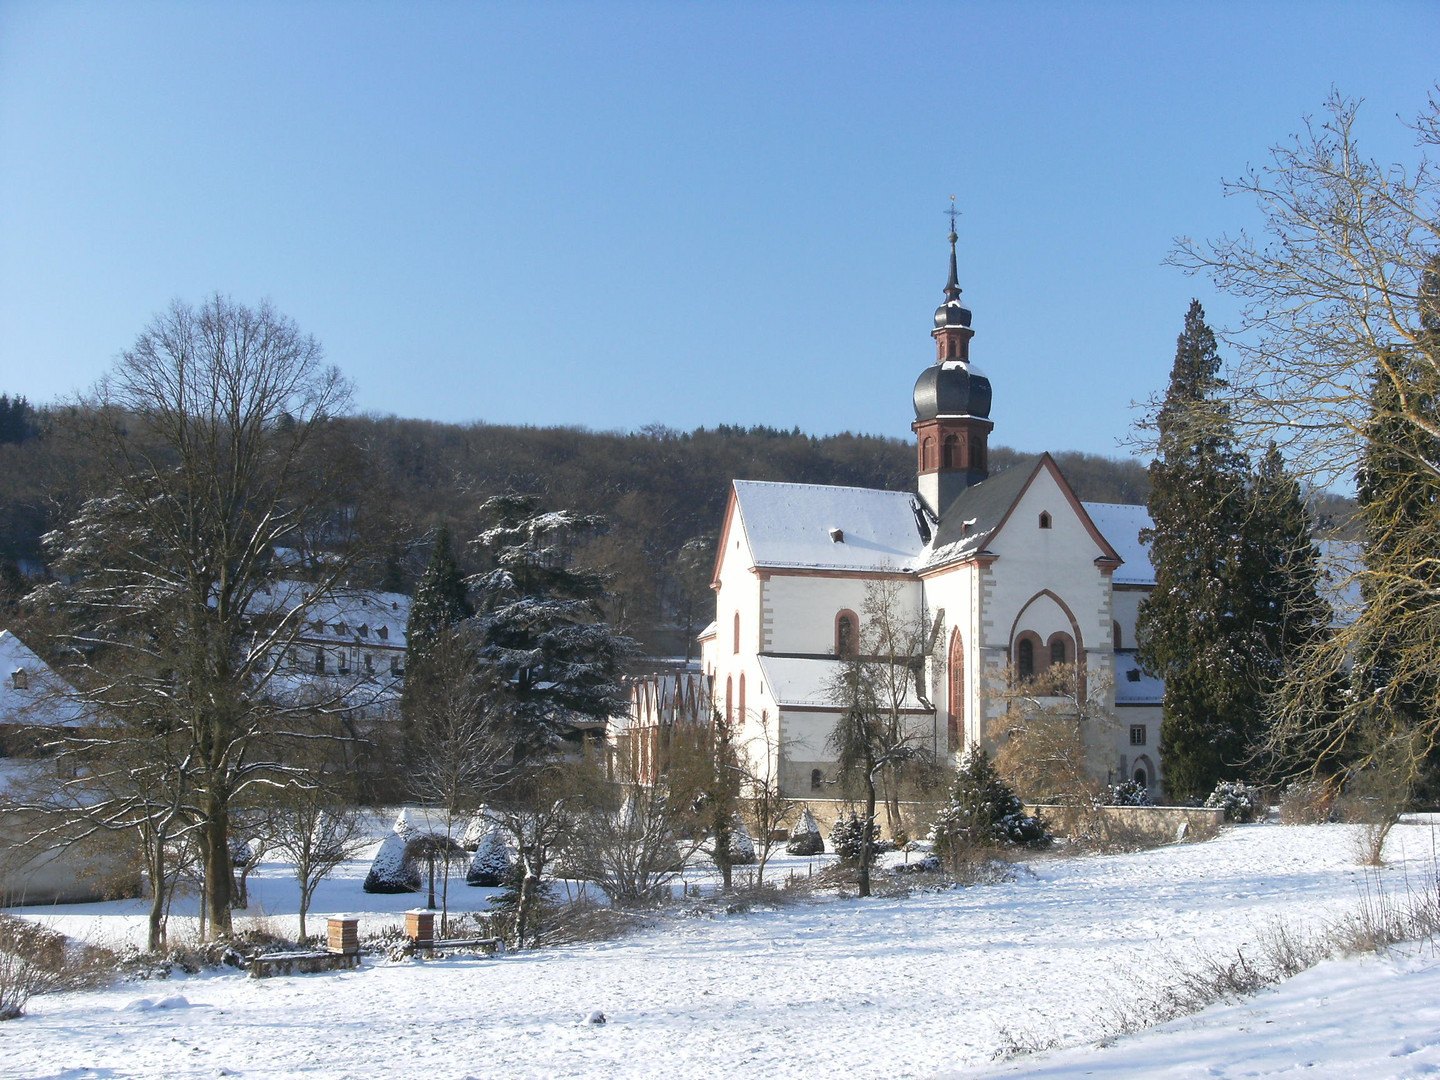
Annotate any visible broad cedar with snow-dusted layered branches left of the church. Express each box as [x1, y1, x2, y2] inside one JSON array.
[[469, 495, 634, 762]]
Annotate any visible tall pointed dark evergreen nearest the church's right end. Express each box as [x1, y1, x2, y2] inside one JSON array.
[[1136, 301, 1263, 801]]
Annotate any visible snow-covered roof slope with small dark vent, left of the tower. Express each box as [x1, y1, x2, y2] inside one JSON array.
[[734, 480, 924, 570]]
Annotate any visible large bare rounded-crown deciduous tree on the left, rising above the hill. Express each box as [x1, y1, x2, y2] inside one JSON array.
[[35, 297, 357, 933]]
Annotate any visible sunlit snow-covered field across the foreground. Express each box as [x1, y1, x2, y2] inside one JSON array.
[[0, 822, 1440, 1080]]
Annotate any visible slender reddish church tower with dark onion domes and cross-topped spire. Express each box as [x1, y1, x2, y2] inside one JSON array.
[[910, 210, 995, 517]]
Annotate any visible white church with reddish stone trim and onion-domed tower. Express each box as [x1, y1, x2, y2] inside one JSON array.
[[701, 229, 1164, 799]]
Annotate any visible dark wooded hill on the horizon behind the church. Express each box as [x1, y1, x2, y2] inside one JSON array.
[[0, 412, 1148, 652]]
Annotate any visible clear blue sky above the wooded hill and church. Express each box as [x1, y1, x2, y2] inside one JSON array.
[[0, 0, 1440, 454]]
